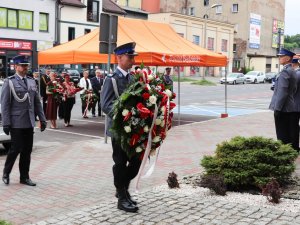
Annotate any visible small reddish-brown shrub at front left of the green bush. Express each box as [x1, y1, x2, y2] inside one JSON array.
[[198, 174, 226, 196]]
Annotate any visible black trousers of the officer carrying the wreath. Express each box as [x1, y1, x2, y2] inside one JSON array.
[[111, 137, 142, 189]]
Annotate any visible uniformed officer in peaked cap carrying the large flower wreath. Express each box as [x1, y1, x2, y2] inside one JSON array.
[[101, 42, 141, 212]]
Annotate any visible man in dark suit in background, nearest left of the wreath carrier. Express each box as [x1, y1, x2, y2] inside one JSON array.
[[91, 69, 104, 117]]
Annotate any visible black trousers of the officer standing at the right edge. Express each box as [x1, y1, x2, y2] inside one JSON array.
[[274, 112, 299, 151]]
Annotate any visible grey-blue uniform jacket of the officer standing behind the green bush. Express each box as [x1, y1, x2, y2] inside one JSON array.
[[269, 64, 297, 112]]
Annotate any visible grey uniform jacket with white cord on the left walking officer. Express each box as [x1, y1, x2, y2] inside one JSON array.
[[1, 74, 46, 128]]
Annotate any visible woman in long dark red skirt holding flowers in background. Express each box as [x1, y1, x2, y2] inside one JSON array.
[[46, 72, 60, 129]]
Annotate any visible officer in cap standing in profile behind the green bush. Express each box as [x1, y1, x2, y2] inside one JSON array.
[[269, 48, 299, 151]]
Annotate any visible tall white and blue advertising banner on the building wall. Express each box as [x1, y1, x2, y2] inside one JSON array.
[[249, 13, 261, 49]]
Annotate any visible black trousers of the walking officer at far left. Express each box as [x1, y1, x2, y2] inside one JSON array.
[[3, 128, 33, 179]]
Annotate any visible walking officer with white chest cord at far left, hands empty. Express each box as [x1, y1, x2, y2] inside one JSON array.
[[1, 55, 47, 186]]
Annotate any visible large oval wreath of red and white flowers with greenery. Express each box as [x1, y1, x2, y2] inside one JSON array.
[[111, 69, 176, 160]]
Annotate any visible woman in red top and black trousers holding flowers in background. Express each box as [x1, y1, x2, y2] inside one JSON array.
[[62, 74, 80, 127]]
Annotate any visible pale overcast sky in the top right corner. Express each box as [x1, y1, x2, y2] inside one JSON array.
[[284, 0, 300, 35]]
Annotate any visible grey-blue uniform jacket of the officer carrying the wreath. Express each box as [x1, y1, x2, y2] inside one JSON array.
[[101, 69, 132, 136]]
